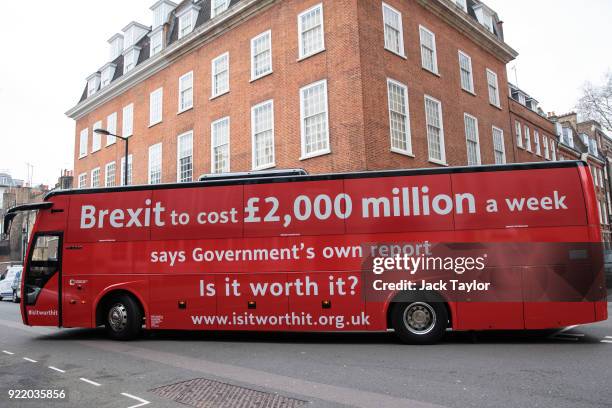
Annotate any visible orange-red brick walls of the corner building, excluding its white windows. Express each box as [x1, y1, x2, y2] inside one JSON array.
[[74, 0, 520, 185]]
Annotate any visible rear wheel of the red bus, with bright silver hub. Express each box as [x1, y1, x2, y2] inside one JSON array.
[[391, 302, 448, 344]]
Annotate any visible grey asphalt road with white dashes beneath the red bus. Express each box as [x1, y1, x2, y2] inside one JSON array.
[[0, 301, 612, 408]]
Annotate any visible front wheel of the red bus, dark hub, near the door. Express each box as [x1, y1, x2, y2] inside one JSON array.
[[105, 295, 142, 340]]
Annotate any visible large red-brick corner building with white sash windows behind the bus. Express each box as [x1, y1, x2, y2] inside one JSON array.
[[67, 0, 516, 187]]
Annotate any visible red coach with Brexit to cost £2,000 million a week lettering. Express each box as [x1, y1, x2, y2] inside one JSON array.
[[4, 161, 607, 343]]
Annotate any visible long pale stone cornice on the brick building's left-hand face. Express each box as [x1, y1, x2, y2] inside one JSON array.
[[65, 0, 276, 120]]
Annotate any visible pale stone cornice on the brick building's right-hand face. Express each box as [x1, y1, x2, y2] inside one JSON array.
[[417, 0, 518, 64]]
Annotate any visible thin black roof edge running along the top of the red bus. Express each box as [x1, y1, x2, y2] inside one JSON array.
[[44, 160, 587, 201]]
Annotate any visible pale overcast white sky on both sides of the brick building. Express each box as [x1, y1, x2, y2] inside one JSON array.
[[0, 0, 612, 185]]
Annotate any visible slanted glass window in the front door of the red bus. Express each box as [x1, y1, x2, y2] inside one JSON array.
[[24, 235, 60, 305]]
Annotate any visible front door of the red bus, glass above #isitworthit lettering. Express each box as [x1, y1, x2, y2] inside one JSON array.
[[22, 232, 62, 326]]
